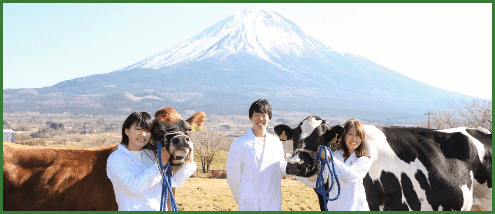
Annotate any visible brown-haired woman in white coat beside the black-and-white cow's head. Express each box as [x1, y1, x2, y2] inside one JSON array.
[[298, 119, 371, 211]]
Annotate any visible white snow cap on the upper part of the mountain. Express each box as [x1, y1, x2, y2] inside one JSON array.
[[122, 9, 330, 70]]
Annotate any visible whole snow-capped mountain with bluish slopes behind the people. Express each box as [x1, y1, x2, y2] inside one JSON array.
[[3, 9, 473, 122]]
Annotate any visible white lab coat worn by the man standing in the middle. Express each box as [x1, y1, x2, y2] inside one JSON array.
[[226, 128, 287, 211]]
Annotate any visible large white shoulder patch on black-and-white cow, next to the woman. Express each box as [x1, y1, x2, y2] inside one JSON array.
[[363, 125, 433, 210]]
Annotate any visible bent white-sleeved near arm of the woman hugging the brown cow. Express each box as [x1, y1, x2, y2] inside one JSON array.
[[107, 156, 162, 195]]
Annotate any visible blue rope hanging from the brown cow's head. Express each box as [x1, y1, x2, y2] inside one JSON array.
[[156, 141, 178, 211]]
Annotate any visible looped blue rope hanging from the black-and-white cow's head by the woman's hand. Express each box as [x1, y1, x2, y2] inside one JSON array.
[[316, 146, 340, 211]]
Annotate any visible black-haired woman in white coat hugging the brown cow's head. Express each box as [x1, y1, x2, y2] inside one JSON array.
[[107, 112, 197, 211]]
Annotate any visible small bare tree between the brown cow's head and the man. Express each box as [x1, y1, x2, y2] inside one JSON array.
[[191, 128, 228, 173]]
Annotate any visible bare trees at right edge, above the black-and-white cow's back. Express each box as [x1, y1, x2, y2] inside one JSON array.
[[432, 98, 492, 131]]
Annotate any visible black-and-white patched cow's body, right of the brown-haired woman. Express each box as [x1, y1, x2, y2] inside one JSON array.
[[363, 126, 491, 210]]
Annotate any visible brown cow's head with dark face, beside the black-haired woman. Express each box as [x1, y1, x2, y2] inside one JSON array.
[[151, 107, 206, 171]]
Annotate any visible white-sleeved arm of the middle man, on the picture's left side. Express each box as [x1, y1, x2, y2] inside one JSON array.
[[226, 141, 242, 204]]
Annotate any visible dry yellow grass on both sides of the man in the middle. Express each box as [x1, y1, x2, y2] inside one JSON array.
[[176, 178, 320, 211]]
